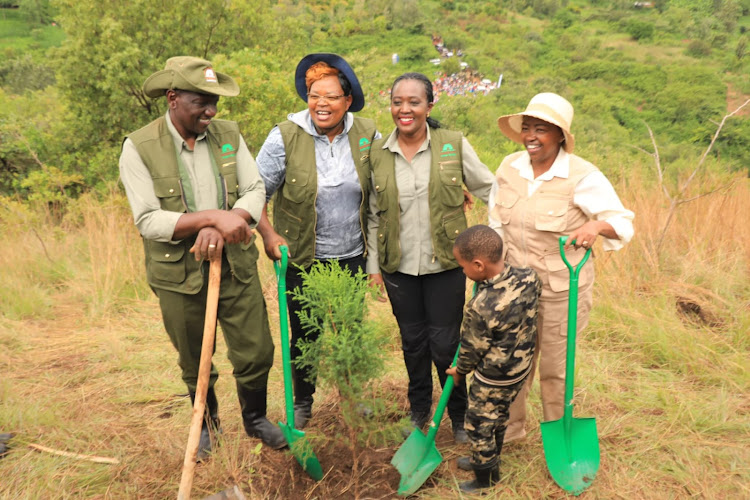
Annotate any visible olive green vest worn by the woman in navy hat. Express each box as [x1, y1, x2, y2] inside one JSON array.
[[273, 117, 377, 268]]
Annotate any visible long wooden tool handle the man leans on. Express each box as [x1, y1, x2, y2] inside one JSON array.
[[177, 256, 221, 500]]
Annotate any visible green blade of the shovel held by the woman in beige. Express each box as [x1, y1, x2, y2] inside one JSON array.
[[541, 418, 599, 495]]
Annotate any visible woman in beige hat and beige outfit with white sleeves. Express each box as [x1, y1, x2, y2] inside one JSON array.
[[489, 93, 633, 442]]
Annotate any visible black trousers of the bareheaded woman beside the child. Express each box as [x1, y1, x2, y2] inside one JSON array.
[[383, 267, 466, 423]]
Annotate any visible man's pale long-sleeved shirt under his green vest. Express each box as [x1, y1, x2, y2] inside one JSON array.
[[120, 111, 265, 242]]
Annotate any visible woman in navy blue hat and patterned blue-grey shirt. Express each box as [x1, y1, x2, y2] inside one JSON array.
[[256, 53, 380, 429]]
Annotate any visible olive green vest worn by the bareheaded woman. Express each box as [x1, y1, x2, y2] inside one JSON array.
[[370, 128, 467, 273]]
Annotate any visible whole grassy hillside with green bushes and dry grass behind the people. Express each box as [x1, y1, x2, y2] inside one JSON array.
[[0, 0, 750, 500]]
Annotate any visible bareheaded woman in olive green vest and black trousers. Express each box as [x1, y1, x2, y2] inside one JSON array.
[[367, 73, 494, 442]]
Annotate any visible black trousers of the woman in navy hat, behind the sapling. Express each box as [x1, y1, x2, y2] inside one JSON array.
[[286, 255, 365, 401]]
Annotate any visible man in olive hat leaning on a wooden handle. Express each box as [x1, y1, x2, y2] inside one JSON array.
[[120, 56, 287, 460]]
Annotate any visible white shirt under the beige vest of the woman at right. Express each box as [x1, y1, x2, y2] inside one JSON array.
[[489, 148, 635, 251]]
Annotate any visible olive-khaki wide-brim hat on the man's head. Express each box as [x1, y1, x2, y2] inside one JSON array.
[[143, 56, 240, 97]]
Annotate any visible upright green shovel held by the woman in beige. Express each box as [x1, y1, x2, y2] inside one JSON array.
[[541, 236, 599, 495]]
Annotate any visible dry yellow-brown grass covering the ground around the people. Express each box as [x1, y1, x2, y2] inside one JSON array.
[[0, 174, 750, 499]]
